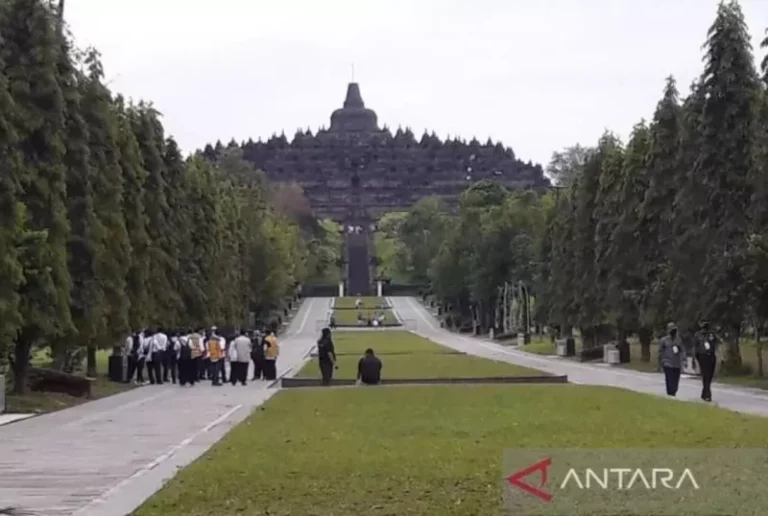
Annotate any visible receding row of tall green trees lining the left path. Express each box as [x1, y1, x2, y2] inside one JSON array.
[[0, 0, 318, 392]]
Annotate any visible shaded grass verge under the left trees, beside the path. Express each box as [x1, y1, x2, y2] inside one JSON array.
[[5, 350, 134, 414]]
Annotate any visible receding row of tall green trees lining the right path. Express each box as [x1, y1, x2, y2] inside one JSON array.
[[388, 1, 768, 373]]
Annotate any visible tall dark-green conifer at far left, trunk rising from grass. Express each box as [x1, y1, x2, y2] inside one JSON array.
[[0, 0, 72, 392]]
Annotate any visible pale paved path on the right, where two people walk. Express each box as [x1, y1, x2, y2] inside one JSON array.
[[390, 297, 768, 416]]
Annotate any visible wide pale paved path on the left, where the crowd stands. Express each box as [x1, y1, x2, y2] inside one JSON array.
[[0, 299, 328, 516]]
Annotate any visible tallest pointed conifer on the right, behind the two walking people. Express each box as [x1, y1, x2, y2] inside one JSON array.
[[692, 1, 759, 369]]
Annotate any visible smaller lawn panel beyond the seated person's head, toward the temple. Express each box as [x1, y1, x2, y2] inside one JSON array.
[[333, 330, 453, 356]]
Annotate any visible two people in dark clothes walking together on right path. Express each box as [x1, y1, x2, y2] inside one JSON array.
[[659, 321, 720, 402]]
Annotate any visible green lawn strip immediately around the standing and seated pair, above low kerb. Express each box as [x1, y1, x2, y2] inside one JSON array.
[[297, 353, 546, 379]]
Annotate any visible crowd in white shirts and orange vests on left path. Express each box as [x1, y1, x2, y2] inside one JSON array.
[[124, 325, 280, 386]]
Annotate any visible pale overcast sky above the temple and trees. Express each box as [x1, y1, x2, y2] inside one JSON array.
[[65, 0, 768, 164]]
